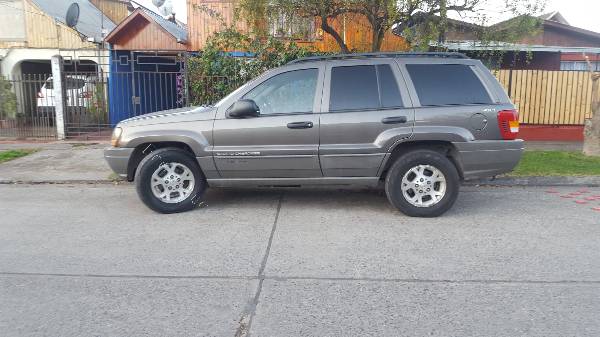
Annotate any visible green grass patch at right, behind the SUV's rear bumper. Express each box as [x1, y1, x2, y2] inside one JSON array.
[[510, 151, 600, 176]]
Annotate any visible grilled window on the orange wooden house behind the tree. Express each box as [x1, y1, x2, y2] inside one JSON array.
[[269, 13, 316, 41]]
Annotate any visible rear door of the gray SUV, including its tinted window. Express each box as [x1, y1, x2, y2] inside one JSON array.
[[319, 59, 414, 177]]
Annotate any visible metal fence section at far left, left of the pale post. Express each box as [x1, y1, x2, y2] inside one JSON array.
[[0, 74, 56, 139]]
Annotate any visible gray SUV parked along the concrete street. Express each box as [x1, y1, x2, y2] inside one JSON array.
[[105, 53, 523, 217]]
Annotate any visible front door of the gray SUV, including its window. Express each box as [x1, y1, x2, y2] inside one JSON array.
[[213, 67, 324, 178]]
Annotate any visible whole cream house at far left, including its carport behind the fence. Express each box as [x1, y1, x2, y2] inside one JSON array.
[[0, 0, 130, 137]]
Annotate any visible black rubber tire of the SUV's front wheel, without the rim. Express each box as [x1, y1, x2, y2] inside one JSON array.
[[135, 148, 207, 214]]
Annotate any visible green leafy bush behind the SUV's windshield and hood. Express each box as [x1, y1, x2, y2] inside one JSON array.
[[187, 29, 322, 105]]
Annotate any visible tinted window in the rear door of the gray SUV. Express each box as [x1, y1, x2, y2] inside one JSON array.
[[329, 64, 402, 111]]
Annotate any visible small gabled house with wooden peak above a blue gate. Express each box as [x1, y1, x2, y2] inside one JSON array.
[[106, 6, 188, 125]]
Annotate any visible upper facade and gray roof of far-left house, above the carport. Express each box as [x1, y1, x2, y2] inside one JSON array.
[[0, 0, 129, 77]]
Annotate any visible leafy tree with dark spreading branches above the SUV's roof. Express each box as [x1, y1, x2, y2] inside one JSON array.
[[240, 0, 545, 52]]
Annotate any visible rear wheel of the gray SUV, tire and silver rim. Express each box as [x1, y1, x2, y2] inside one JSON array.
[[385, 149, 460, 217]]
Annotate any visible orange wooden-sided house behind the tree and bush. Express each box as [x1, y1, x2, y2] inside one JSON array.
[[187, 0, 408, 52]]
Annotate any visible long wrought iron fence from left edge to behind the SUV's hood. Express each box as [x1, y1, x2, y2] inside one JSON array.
[[0, 51, 247, 139]]
